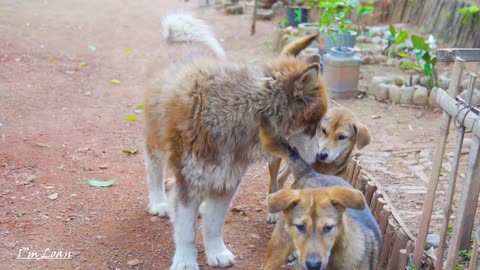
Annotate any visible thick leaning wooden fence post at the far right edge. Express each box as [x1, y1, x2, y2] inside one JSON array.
[[446, 137, 480, 269]]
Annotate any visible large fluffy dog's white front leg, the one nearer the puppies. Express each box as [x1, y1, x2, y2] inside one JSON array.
[[202, 191, 235, 267]]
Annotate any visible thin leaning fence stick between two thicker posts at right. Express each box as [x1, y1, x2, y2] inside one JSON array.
[[435, 74, 477, 269]]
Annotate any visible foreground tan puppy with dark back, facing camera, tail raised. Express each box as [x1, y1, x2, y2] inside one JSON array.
[[259, 118, 382, 270]]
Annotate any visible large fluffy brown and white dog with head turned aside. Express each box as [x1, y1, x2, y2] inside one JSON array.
[[144, 14, 328, 270]]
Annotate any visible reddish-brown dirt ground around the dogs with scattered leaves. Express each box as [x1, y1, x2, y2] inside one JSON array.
[[0, 0, 472, 269]]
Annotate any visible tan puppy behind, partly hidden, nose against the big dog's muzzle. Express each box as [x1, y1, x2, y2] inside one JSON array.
[[268, 107, 371, 223]]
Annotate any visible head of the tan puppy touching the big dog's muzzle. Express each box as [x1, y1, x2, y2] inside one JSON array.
[[316, 108, 370, 163]]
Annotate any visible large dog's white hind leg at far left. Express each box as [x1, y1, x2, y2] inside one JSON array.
[[145, 153, 169, 217]]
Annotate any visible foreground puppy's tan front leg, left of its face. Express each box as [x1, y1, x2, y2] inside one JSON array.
[[261, 220, 294, 270]]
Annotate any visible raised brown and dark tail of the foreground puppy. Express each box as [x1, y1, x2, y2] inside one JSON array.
[[259, 117, 313, 179]]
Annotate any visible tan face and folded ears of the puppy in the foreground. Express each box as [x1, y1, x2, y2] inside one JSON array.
[[268, 186, 365, 270]]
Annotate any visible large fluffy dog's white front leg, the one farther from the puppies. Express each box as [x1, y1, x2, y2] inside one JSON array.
[[170, 200, 200, 270]]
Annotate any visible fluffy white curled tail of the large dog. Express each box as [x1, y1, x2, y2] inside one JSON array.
[[162, 13, 225, 57]]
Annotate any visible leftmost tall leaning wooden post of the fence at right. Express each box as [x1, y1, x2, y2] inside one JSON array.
[[413, 57, 465, 267]]
